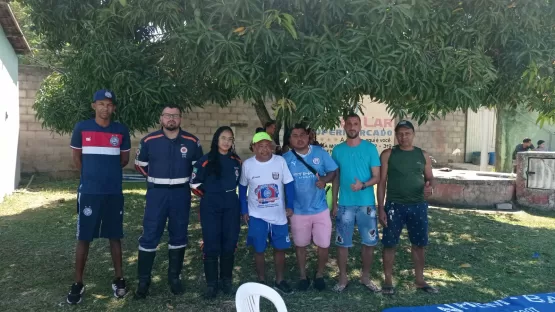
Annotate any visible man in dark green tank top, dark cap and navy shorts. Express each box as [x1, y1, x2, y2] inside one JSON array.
[[378, 120, 438, 295]]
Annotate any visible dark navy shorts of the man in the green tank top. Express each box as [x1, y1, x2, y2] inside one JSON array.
[[382, 202, 428, 247]]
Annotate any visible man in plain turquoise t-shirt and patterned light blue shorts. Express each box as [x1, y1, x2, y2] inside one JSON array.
[[332, 114, 380, 292]]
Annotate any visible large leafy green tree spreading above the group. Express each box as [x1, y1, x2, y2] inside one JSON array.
[[21, 0, 555, 133]]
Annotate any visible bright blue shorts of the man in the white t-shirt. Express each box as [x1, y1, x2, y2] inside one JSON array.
[[247, 217, 291, 253]]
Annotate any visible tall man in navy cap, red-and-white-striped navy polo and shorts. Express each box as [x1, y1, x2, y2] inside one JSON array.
[[67, 90, 131, 304]]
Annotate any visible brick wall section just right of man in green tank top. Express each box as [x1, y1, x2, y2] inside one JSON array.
[[406, 111, 466, 165]]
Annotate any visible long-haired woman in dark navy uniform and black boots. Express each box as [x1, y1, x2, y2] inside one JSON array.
[[191, 127, 241, 299]]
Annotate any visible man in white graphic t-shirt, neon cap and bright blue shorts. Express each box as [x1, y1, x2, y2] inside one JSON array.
[[239, 132, 295, 294]]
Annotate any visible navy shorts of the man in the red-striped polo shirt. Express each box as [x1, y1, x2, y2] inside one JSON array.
[[77, 193, 123, 242]]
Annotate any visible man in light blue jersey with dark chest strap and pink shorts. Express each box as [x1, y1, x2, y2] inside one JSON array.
[[283, 125, 337, 291]]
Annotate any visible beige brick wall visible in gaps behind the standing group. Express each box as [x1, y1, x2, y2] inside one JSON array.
[[19, 66, 466, 174]]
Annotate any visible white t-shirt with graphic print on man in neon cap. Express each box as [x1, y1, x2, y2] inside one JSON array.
[[239, 155, 293, 225]]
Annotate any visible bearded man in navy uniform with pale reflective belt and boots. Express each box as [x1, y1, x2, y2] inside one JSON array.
[[135, 105, 203, 298]]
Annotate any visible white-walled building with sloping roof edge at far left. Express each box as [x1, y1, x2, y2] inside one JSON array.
[[0, 2, 30, 202]]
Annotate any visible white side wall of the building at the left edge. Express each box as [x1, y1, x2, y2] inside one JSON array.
[[0, 27, 20, 202]]
